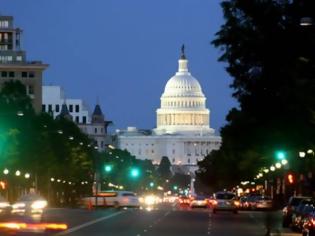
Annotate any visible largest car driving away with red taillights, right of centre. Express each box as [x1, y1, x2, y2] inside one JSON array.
[[212, 191, 240, 214]]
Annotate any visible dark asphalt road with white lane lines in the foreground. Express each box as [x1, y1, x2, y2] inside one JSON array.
[[0, 205, 299, 236]]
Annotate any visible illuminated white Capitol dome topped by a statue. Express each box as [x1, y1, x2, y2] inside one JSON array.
[[155, 47, 214, 134]]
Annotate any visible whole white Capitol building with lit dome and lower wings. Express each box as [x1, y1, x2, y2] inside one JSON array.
[[116, 47, 221, 171]]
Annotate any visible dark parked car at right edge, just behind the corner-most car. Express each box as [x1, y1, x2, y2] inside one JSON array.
[[291, 199, 315, 232]]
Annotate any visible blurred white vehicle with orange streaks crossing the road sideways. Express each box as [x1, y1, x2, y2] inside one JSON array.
[[82, 191, 140, 208]]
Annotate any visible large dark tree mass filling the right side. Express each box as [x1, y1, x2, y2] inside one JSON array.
[[199, 0, 315, 187]]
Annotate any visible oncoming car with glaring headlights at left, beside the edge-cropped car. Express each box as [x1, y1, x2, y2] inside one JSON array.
[[11, 193, 48, 215]]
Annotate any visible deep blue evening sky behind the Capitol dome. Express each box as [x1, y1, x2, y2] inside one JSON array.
[[0, 0, 236, 131]]
